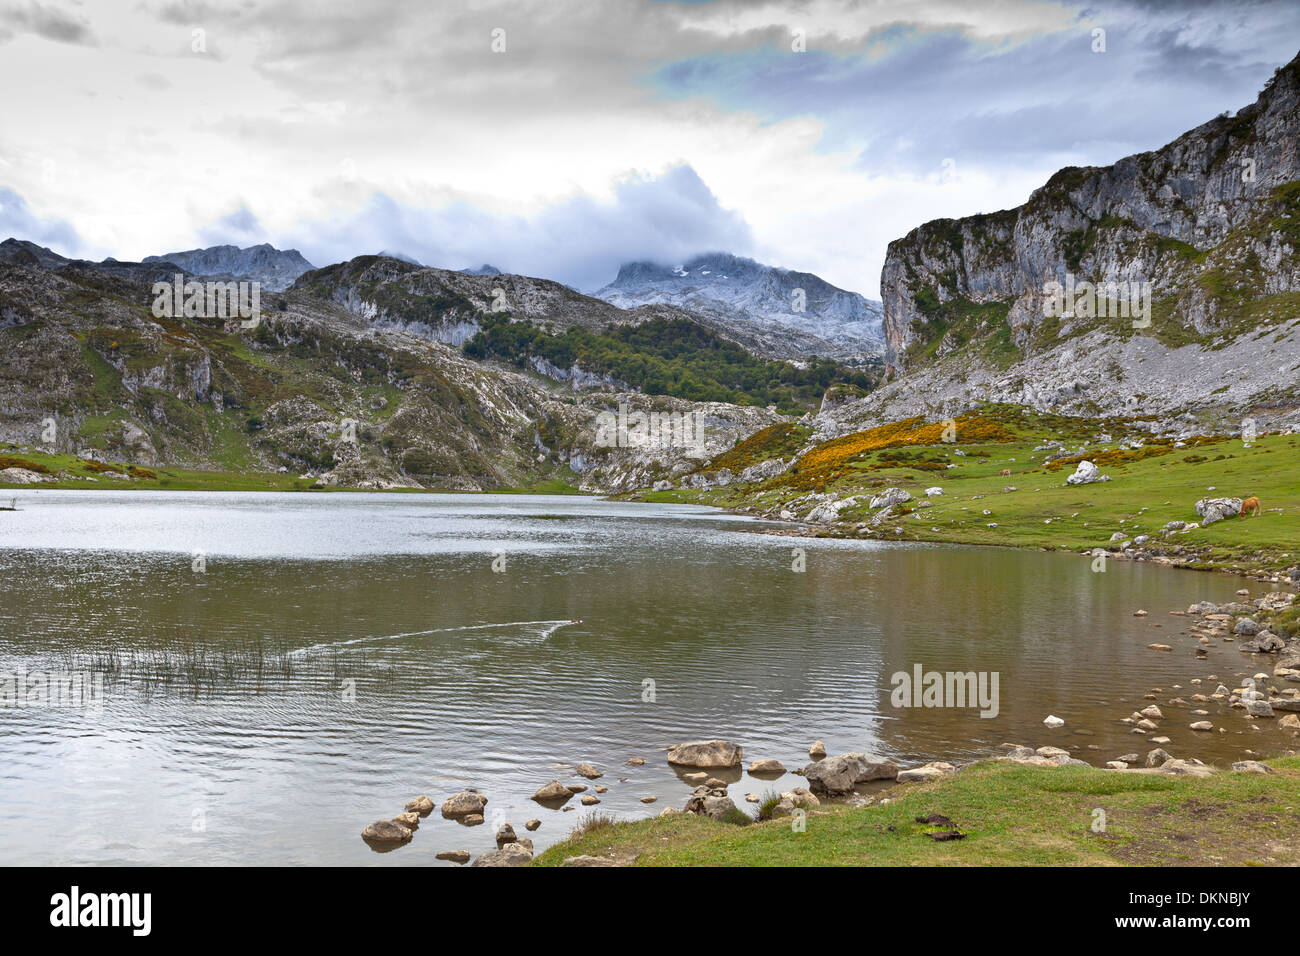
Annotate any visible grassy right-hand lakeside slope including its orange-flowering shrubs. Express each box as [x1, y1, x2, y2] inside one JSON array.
[[637, 406, 1300, 571]]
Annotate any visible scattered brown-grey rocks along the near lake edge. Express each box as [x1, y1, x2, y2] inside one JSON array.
[[361, 588, 1300, 866]]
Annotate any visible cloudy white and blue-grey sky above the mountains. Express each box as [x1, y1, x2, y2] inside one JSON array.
[[0, 0, 1300, 297]]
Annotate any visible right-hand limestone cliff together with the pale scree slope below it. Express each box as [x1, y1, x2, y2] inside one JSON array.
[[845, 47, 1300, 421]]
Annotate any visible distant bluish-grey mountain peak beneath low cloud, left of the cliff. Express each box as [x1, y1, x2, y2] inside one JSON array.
[[597, 252, 881, 360]]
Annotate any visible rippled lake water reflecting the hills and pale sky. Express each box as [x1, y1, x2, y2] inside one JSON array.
[[0, 490, 1258, 865]]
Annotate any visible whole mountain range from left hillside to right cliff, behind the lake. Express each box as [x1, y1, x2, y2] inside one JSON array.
[[0, 47, 1300, 490]]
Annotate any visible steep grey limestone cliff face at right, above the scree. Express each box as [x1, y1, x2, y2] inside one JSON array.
[[881, 50, 1300, 373]]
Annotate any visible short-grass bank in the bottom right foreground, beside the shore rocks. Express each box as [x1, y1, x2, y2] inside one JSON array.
[[533, 757, 1300, 866]]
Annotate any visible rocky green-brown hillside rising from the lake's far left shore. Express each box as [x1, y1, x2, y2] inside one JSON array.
[[0, 252, 780, 490]]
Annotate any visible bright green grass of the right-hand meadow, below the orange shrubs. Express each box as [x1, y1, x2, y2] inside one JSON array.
[[650, 407, 1300, 568]]
